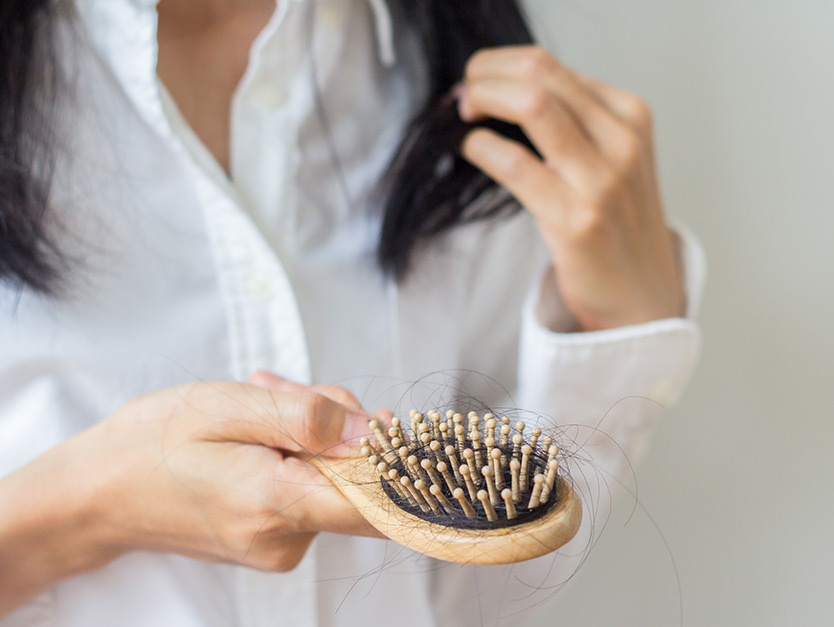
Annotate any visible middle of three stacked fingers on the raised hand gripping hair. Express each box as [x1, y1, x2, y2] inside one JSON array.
[[462, 78, 605, 190]]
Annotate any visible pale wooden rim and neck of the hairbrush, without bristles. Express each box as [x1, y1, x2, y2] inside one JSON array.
[[309, 457, 582, 564]]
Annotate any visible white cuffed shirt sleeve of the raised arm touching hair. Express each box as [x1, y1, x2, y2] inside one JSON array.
[[426, 226, 705, 624]]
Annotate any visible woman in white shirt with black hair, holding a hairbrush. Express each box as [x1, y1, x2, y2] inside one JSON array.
[[0, 0, 701, 625]]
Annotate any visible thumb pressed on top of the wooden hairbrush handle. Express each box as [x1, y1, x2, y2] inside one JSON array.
[[182, 383, 373, 456]]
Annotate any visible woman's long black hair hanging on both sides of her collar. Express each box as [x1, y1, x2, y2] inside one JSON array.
[[0, 0, 532, 293]]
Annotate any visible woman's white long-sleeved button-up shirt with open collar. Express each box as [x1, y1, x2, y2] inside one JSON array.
[[0, 0, 704, 627]]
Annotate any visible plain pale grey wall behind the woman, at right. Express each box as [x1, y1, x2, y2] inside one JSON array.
[[530, 0, 834, 627]]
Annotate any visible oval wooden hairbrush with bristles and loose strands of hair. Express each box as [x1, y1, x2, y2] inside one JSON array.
[[310, 410, 582, 564]]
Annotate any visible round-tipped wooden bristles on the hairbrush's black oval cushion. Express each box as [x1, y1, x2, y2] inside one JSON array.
[[362, 410, 559, 529]]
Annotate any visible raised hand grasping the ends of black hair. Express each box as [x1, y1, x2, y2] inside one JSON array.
[[459, 46, 685, 331]]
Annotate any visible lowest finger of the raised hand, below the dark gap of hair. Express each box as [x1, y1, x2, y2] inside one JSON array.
[[461, 129, 572, 229]]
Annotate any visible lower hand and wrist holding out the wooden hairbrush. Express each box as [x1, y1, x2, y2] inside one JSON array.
[[0, 383, 378, 616]]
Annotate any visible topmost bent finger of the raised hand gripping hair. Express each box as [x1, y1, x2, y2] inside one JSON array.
[[467, 46, 637, 166]]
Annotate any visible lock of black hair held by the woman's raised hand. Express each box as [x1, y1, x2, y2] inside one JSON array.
[[377, 0, 532, 280]]
